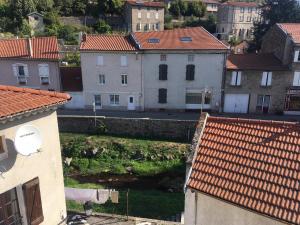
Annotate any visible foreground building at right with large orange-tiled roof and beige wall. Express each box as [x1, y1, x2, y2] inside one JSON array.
[[184, 115, 300, 225]]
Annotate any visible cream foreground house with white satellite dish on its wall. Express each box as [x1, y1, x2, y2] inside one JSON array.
[[0, 85, 70, 225]]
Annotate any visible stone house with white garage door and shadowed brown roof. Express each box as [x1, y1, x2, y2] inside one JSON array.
[[224, 54, 294, 114]]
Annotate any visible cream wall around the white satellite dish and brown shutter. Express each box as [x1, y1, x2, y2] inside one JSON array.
[[0, 112, 66, 225]]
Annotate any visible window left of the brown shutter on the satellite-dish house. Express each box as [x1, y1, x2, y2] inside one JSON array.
[[0, 188, 23, 225]]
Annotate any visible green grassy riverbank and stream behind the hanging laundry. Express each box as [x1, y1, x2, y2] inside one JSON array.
[[60, 133, 189, 220]]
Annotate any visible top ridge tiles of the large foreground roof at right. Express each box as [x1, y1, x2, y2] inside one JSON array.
[[208, 116, 300, 126]]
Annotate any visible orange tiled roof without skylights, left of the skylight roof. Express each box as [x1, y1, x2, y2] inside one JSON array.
[[80, 35, 137, 51]]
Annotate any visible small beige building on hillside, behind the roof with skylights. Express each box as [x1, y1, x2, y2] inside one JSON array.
[[125, 0, 164, 32]]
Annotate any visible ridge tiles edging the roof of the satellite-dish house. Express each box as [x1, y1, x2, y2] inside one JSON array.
[[0, 85, 71, 100]]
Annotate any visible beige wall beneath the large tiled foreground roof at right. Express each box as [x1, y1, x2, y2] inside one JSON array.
[[184, 189, 285, 225]]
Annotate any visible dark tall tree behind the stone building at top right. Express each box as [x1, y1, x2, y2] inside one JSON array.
[[249, 0, 300, 51]]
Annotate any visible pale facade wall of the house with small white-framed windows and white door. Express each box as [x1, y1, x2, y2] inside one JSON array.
[[80, 52, 143, 110]]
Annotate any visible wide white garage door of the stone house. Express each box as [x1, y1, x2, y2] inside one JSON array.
[[224, 94, 249, 113]]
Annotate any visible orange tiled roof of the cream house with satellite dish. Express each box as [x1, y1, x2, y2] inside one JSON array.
[[0, 85, 71, 120]]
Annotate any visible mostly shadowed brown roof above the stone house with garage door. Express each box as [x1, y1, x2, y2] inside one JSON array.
[[226, 53, 288, 71]]
